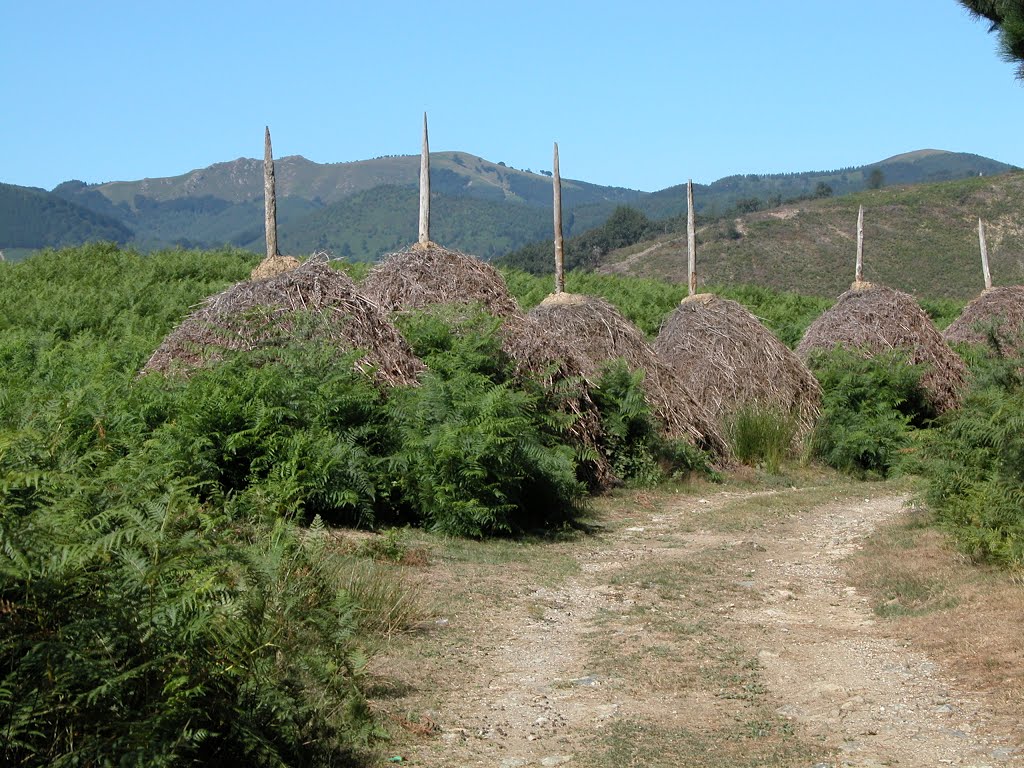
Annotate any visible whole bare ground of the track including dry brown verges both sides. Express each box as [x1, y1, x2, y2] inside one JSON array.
[[371, 482, 1024, 768]]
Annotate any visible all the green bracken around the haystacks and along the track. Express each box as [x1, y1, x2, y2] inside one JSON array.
[[0, 244, 1024, 766]]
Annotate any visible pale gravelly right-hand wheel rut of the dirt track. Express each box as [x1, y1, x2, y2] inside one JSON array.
[[731, 497, 1024, 768]]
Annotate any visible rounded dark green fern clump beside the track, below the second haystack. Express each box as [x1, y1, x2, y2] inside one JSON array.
[[390, 373, 584, 538]]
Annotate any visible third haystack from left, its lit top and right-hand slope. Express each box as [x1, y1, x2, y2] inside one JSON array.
[[529, 293, 726, 456]]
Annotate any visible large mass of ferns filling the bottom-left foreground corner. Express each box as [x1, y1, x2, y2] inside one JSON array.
[[0, 461, 373, 766]]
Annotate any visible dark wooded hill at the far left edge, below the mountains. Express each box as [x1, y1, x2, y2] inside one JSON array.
[[0, 183, 133, 256]]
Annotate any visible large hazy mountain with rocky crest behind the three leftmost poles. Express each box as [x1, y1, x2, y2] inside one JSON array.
[[48, 152, 646, 260]]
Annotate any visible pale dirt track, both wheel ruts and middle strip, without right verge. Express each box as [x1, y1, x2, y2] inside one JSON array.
[[376, 490, 1024, 768]]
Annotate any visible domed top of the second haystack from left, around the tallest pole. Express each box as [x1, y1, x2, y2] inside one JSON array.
[[360, 242, 519, 317]]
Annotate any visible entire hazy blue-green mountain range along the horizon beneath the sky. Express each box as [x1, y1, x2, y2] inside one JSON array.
[[0, 151, 1012, 260]]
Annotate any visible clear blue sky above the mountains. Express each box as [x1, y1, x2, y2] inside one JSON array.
[[6, 0, 1024, 190]]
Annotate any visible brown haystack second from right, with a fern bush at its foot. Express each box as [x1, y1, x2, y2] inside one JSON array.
[[797, 283, 967, 412]]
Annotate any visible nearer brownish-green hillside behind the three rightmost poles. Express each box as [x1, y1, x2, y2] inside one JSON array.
[[599, 171, 1024, 299]]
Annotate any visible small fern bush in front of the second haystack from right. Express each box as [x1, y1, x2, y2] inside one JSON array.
[[811, 349, 935, 477]]
